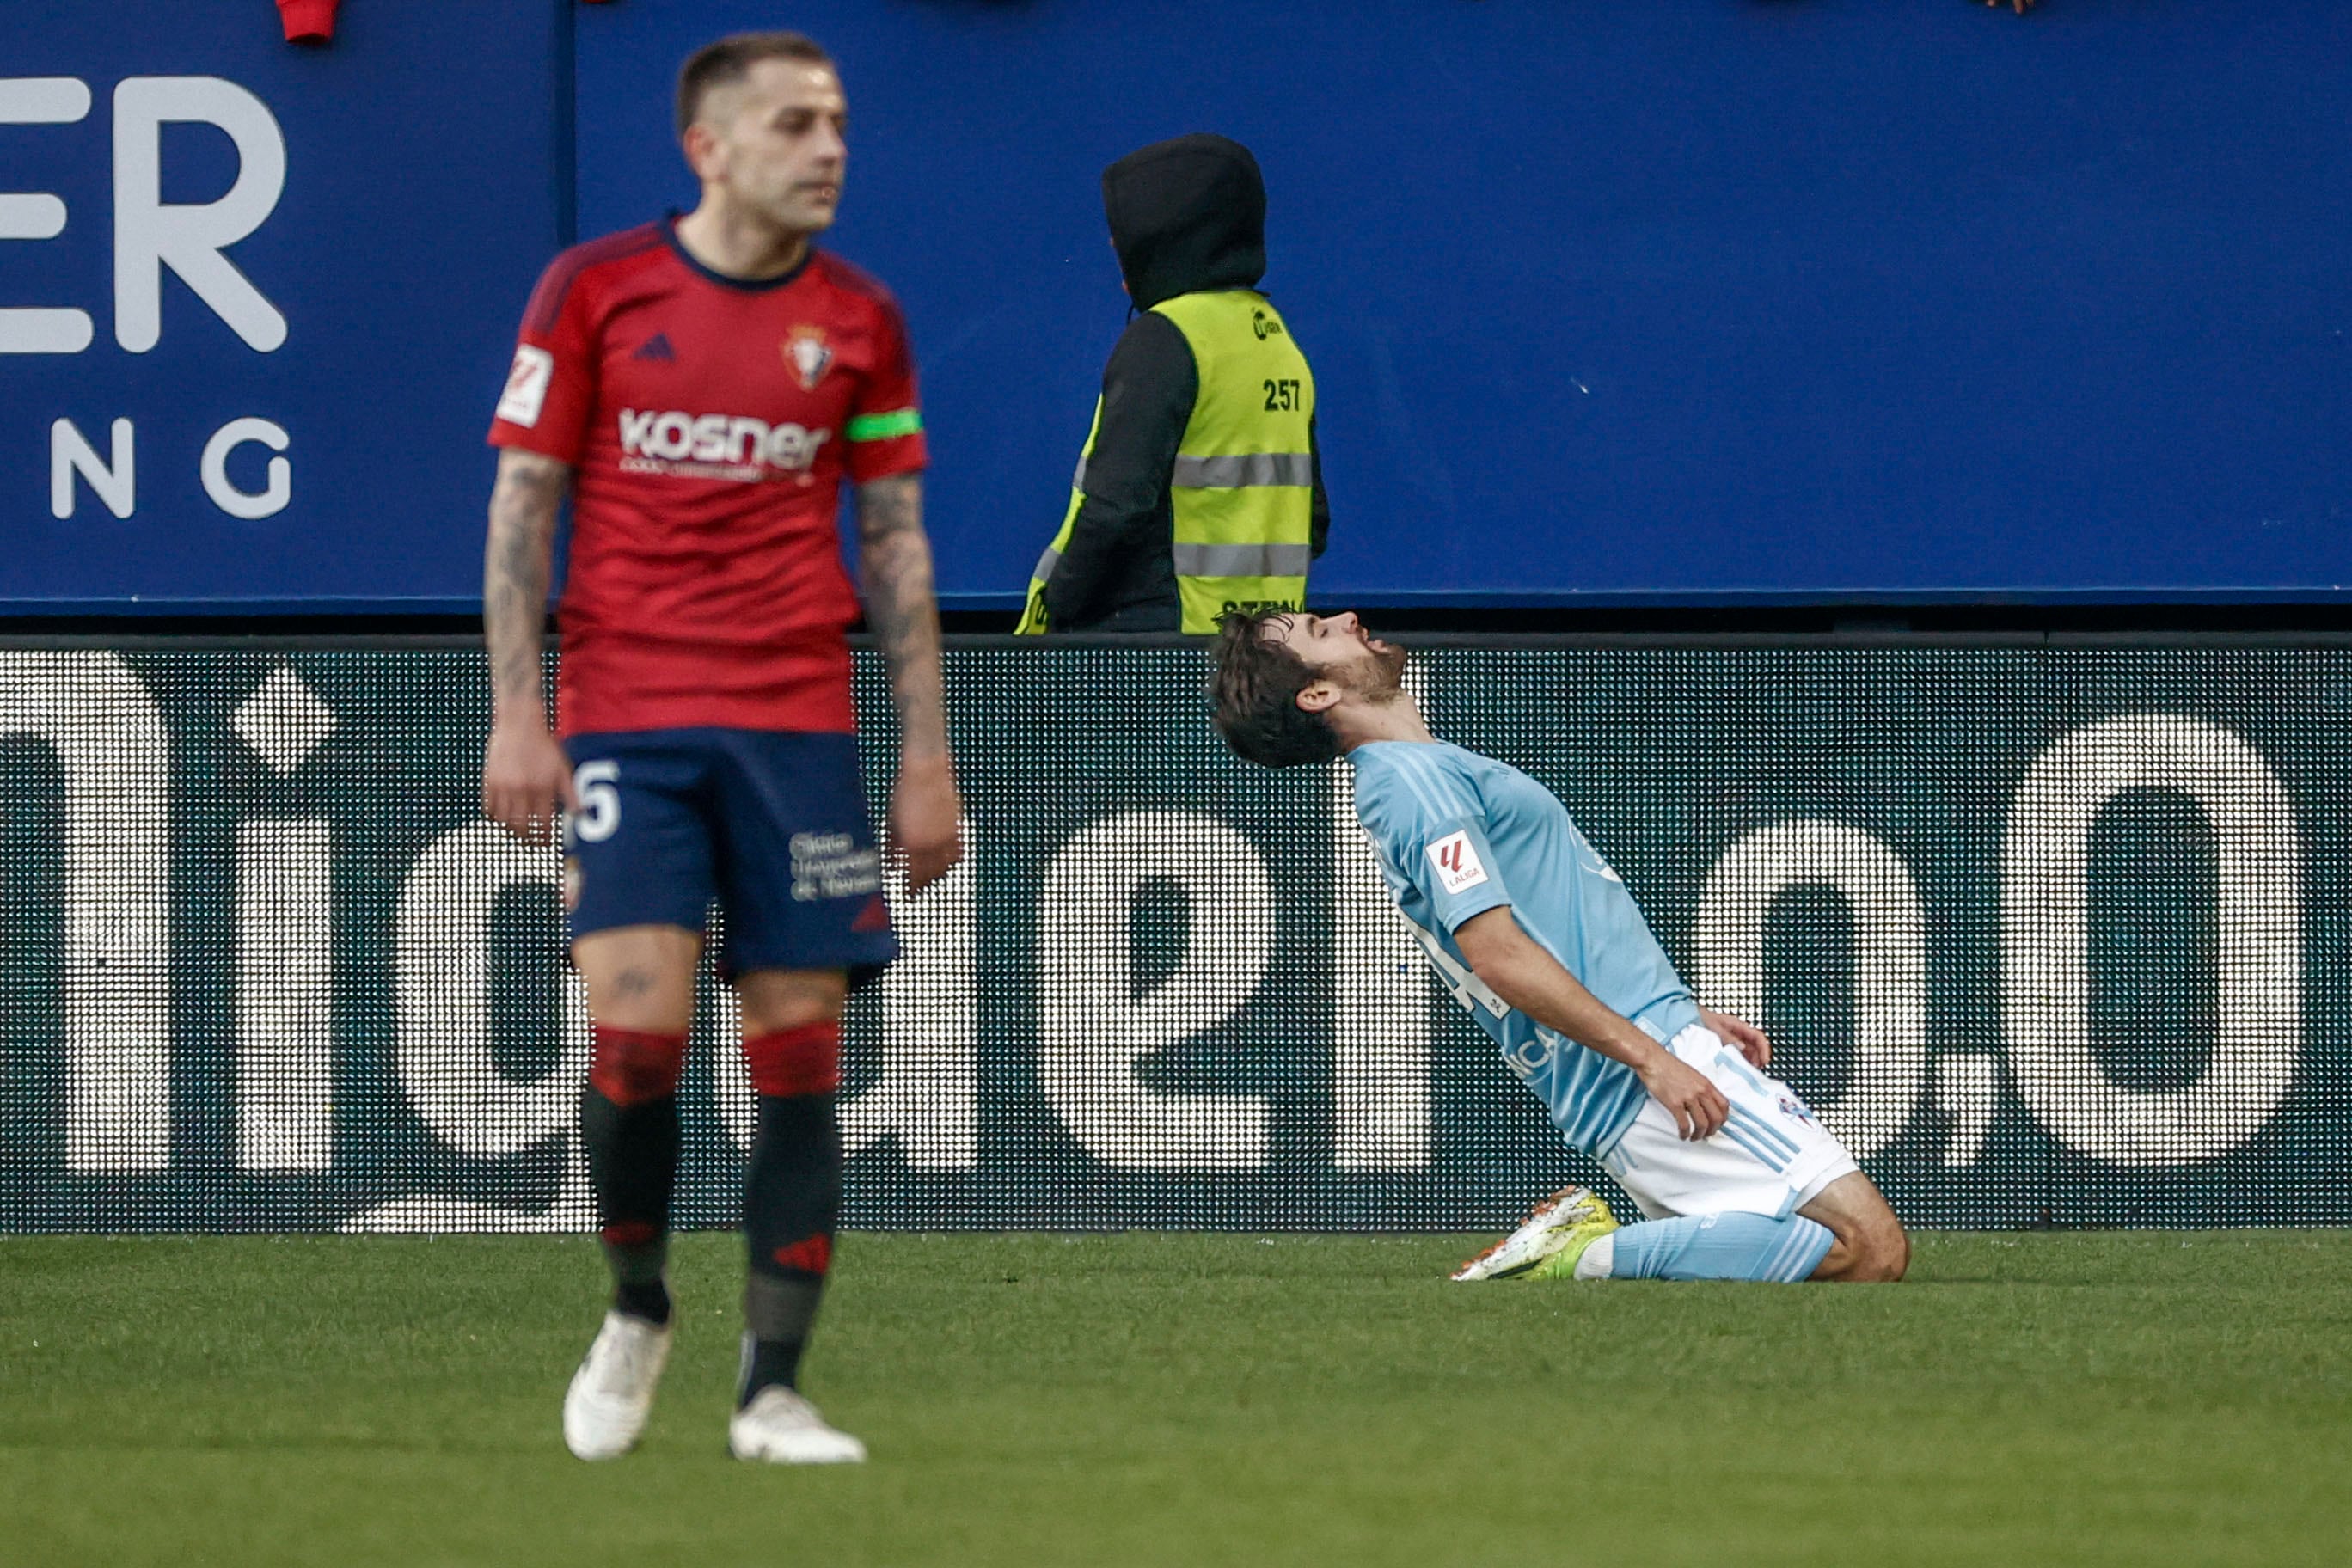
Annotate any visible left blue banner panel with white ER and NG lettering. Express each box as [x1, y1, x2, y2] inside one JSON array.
[[0, 0, 569, 614]]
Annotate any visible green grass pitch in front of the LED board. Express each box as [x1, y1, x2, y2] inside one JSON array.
[[0, 1232, 2352, 1568]]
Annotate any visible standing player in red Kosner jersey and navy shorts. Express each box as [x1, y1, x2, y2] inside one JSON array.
[[482, 33, 962, 1462]]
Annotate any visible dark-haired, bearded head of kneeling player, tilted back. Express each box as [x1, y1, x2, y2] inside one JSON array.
[[1209, 609, 1404, 769]]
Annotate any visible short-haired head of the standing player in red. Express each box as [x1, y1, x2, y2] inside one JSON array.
[[677, 33, 849, 235]]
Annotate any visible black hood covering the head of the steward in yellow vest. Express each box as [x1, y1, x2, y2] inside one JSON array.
[[1103, 134, 1265, 310]]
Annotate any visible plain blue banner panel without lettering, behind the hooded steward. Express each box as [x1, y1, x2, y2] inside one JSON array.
[[579, 0, 2352, 607]]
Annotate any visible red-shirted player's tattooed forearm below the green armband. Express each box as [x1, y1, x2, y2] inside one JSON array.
[[859, 473, 965, 893]]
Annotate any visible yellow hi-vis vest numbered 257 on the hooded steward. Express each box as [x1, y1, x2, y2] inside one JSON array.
[[1014, 289, 1314, 633]]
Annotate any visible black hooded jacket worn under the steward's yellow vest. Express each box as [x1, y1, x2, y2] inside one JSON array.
[[1044, 137, 1332, 633]]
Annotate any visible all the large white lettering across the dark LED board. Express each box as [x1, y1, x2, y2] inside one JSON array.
[[0, 651, 2305, 1229]]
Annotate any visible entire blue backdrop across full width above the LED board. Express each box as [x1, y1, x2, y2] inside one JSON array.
[[0, 0, 2352, 614]]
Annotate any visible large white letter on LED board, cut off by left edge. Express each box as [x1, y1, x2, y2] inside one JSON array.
[[0, 653, 172, 1175]]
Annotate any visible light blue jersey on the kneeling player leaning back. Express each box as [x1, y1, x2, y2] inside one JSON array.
[[1348, 740, 1698, 1156]]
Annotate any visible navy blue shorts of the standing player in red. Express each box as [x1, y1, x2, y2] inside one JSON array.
[[565, 729, 898, 980]]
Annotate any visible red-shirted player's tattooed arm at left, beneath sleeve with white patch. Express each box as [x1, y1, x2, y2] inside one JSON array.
[[482, 447, 576, 844]]
